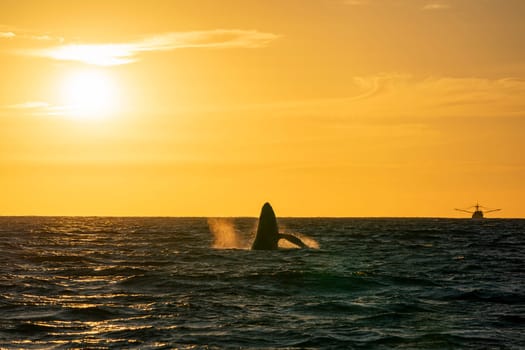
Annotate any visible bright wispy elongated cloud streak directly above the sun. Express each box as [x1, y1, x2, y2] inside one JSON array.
[[17, 29, 279, 66]]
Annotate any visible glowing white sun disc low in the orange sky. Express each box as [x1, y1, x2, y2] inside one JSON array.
[[62, 70, 118, 119]]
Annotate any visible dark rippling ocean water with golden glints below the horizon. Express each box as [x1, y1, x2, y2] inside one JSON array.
[[0, 217, 525, 349]]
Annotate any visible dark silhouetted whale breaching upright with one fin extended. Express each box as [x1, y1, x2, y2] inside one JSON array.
[[252, 202, 308, 250]]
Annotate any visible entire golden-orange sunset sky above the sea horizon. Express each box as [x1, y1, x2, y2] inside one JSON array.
[[0, 0, 525, 217]]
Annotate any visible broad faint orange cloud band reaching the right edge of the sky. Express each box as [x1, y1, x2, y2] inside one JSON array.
[[218, 73, 525, 122]]
